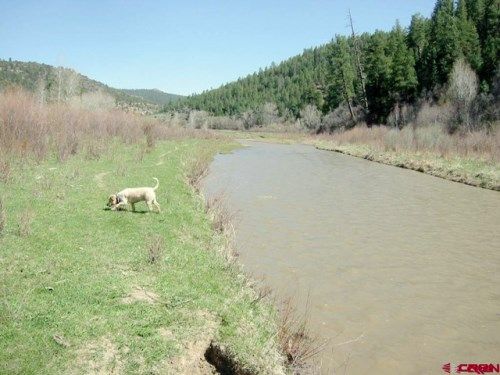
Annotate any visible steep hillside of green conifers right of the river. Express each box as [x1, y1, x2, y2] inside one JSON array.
[[165, 0, 500, 127]]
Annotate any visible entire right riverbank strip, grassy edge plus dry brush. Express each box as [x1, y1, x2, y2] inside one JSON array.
[[224, 127, 500, 190]]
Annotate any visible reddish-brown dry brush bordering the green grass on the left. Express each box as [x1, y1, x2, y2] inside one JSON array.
[[0, 89, 219, 164]]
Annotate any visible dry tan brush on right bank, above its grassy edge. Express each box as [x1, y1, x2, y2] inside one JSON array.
[[323, 125, 500, 162]]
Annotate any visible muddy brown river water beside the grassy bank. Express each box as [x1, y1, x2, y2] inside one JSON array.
[[204, 141, 500, 374]]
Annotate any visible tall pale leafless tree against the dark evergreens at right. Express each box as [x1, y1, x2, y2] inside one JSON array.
[[446, 59, 479, 133]]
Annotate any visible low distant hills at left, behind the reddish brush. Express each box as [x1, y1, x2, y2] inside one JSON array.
[[0, 59, 180, 113]]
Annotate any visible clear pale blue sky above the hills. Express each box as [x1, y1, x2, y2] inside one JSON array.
[[0, 0, 435, 95]]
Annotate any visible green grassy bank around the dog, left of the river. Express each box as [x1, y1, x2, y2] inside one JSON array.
[[0, 139, 283, 374]]
